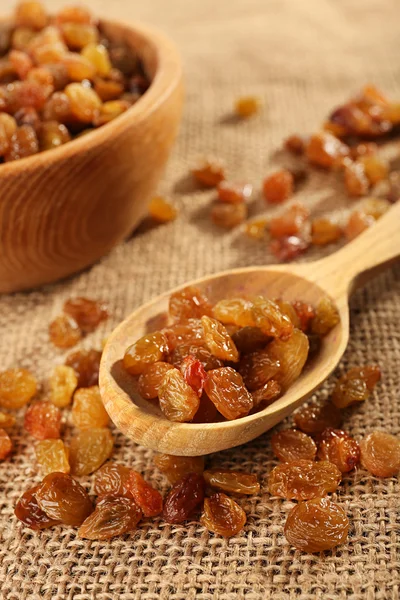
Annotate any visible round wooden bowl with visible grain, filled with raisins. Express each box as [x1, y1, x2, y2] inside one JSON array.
[[0, 21, 183, 292]]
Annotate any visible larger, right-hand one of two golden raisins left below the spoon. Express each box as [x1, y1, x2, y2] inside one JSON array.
[[70, 428, 114, 476]]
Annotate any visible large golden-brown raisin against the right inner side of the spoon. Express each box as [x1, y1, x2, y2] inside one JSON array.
[[266, 329, 309, 390]]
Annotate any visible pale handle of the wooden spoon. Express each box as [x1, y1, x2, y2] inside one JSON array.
[[299, 200, 400, 295]]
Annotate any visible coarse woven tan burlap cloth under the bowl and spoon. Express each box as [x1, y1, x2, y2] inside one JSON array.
[[0, 0, 400, 600]]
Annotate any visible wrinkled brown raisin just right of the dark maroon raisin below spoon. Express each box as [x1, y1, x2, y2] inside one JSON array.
[[200, 492, 246, 537]]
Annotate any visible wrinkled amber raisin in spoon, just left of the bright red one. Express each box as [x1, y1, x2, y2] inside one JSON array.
[[158, 369, 200, 423]]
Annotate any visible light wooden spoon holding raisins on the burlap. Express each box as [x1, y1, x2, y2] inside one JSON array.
[[100, 201, 400, 456]]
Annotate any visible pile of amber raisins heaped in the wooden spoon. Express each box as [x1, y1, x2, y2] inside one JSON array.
[[123, 287, 339, 423]]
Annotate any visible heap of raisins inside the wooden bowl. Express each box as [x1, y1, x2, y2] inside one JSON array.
[[0, 0, 149, 162]]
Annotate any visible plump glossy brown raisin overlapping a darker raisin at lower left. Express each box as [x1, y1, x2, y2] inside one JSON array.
[[35, 473, 93, 527]]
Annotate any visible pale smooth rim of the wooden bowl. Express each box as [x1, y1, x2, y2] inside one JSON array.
[[0, 18, 182, 172]]
